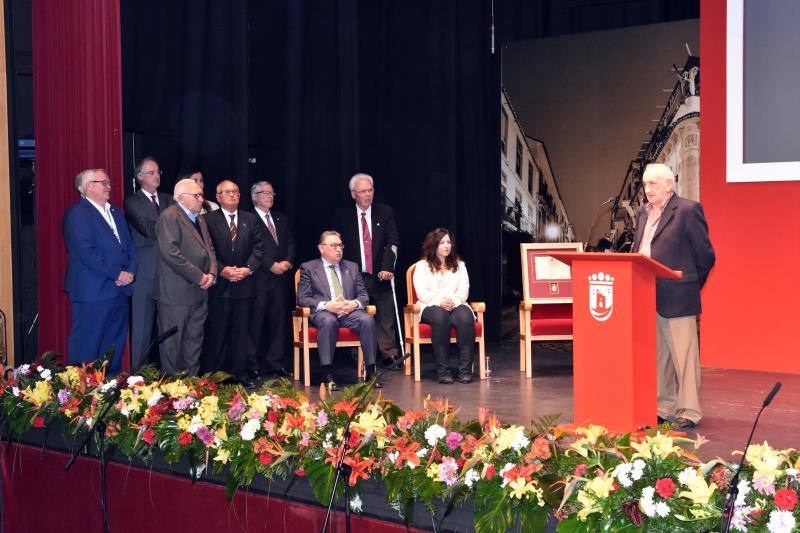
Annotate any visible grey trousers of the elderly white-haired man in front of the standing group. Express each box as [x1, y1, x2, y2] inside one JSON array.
[[158, 299, 208, 376]]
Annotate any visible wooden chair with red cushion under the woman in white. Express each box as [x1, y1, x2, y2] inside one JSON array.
[[403, 263, 486, 381]]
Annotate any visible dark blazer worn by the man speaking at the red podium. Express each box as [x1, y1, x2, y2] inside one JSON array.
[[631, 194, 716, 318]]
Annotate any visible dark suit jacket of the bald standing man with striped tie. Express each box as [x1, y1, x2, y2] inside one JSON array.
[[202, 209, 264, 299]]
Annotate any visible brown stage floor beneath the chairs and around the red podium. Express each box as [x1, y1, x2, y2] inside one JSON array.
[[294, 342, 800, 460]]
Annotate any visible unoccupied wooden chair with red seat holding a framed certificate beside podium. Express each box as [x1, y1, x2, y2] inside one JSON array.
[[519, 242, 583, 378]]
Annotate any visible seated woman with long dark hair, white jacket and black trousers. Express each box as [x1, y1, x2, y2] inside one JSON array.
[[414, 228, 475, 384]]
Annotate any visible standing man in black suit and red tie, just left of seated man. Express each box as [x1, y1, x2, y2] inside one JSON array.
[[248, 181, 295, 379]]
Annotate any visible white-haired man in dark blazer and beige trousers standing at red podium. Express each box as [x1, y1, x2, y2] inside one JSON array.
[[632, 164, 715, 429]]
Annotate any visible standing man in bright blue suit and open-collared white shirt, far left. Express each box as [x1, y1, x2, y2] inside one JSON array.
[[62, 169, 137, 375]]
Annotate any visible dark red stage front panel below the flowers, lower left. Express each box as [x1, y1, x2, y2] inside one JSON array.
[[2, 442, 419, 533]]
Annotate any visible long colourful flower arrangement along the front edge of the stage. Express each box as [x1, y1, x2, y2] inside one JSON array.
[[0, 355, 800, 533]]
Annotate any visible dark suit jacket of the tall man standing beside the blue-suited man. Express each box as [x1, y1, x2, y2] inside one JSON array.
[[122, 189, 175, 281]]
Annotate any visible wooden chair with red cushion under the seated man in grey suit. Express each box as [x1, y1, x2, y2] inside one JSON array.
[[292, 269, 375, 387]]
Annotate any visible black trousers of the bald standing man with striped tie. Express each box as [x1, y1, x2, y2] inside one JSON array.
[[200, 298, 253, 380]]
